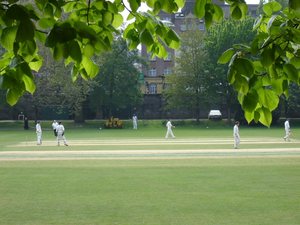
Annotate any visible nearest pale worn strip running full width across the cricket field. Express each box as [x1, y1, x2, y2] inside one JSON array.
[[0, 148, 300, 161]]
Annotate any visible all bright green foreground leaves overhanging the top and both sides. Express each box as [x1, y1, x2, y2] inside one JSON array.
[[0, 0, 300, 126]]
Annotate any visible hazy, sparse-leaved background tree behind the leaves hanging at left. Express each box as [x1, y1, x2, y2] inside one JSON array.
[[18, 47, 93, 122]]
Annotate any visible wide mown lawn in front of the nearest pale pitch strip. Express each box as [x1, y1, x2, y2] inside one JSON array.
[[0, 158, 300, 225]]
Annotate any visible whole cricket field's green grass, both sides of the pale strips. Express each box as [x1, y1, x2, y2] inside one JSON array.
[[0, 123, 300, 225]]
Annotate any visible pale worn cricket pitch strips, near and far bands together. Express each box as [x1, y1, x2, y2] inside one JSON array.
[[0, 138, 300, 161]]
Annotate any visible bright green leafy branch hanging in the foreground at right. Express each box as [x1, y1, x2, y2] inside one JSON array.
[[219, 0, 300, 126]]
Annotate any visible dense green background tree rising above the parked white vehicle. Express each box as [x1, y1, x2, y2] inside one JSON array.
[[205, 17, 255, 121]]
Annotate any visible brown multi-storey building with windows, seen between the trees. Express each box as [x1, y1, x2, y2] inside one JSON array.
[[141, 0, 258, 119]]
